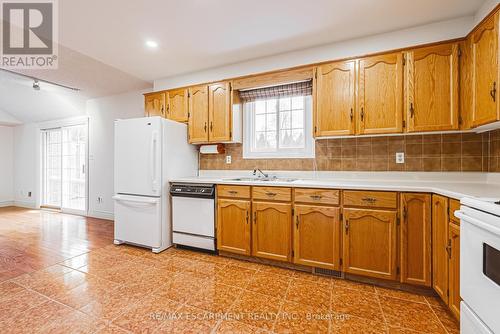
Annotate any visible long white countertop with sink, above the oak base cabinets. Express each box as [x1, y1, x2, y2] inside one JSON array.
[[170, 174, 500, 200]]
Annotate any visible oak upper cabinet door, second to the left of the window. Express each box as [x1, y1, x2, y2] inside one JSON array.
[[188, 85, 208, 143]]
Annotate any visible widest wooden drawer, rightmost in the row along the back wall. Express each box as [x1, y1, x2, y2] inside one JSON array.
[[344, 191, 397, 209]]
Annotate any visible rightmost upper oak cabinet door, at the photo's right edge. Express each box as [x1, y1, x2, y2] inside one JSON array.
[[472, 13, 499, 126]]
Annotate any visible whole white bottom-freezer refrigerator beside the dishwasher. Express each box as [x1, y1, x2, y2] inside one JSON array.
[[113, 117, 198, 253]]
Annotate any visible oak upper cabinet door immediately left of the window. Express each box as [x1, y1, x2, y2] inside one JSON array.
[[208, 82, 231, 143]]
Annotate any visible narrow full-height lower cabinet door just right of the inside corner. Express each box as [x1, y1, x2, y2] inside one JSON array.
[[432, 195, 448, 304]]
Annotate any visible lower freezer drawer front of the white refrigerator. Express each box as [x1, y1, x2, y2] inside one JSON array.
[[113, 195, 162, 248]]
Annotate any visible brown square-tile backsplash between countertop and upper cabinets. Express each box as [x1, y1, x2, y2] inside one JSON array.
[[200, 130, 500, 172]]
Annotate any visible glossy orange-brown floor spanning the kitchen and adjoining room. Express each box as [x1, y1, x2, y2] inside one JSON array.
[[0, 209, 459, 333]]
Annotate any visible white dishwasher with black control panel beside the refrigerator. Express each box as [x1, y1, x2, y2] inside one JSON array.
[[170, 183, 215, 251]]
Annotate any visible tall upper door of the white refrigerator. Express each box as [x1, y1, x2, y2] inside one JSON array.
[[114, 117, 162, 196]]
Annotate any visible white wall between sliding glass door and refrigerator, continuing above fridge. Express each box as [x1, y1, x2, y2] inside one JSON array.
[[87, 92, 144, 219]]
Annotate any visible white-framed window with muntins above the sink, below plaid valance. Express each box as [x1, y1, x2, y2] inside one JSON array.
[[243, 95, 314, 159]]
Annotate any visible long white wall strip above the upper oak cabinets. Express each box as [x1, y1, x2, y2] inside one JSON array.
[[154, 16, 474, 90]]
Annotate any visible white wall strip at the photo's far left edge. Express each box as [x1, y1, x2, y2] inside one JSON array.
[[0, 126, 14, 207]]
